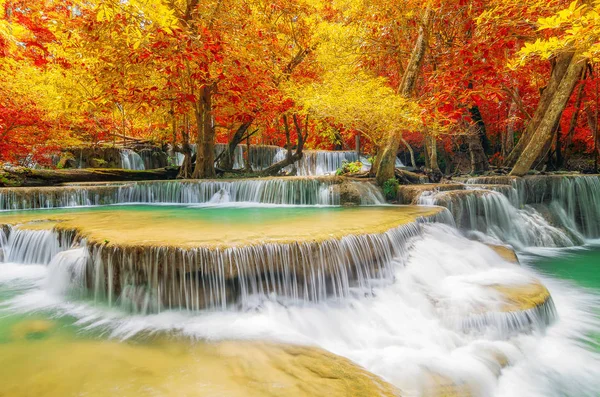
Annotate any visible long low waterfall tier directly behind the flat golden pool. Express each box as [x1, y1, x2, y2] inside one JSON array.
[[0, 177, 385, 211]]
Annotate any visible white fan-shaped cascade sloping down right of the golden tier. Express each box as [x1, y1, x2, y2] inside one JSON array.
[[418, 189, 580, 247]]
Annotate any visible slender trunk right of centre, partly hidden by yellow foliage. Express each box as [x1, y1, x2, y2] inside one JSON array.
[[375, 5, 433, 185]]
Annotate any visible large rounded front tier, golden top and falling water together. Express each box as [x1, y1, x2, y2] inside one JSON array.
[[3, 207, 440, 312]]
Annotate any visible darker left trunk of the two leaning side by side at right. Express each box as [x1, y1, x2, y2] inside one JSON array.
[[504, 53, 574, 167]]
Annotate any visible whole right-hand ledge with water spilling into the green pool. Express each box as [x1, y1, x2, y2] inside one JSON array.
[[399, 175, 600, 247]]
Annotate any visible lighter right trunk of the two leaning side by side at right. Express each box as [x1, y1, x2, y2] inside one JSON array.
[[510, 54, 586, 176]]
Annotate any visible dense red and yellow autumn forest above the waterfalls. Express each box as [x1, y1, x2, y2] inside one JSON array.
[[0, 0, 600, 183]]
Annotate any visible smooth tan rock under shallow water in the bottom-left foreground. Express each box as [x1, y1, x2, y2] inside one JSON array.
[[0, 339, 400, 397]]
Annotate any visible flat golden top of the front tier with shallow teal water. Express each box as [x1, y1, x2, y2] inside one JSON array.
[[0, 206, 441, 248]]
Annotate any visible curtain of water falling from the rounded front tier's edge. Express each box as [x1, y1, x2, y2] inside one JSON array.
[[0, 218, 432, 313]]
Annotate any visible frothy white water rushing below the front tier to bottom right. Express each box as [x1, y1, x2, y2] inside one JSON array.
[[0, 225, 600, 397]]
